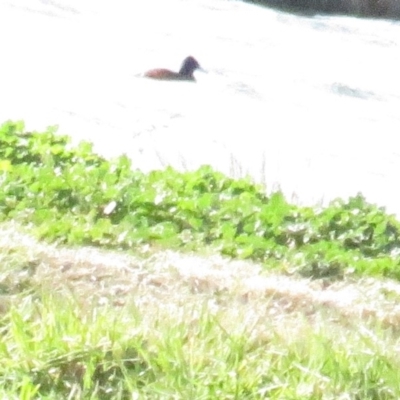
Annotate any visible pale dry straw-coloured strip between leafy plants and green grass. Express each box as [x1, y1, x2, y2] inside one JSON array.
[[0, 223, 400, 329]]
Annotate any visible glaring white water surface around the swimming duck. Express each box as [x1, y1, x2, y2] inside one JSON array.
[[0, 0, 400, 215]]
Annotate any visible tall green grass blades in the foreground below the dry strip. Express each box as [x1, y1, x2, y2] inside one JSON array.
[[0, 294, 400, 399]]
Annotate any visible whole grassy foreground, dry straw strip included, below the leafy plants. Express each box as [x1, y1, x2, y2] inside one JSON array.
[[0, 224, 400, 399]]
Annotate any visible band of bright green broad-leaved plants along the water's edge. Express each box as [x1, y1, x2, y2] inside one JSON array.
[[0, 123, 400, 279]]
